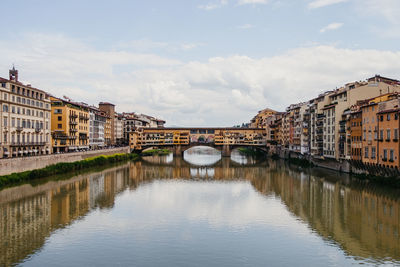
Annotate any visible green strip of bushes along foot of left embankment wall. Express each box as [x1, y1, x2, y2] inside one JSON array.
[[0, 153, 140, 187]]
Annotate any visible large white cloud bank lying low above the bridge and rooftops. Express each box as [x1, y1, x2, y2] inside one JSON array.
[[0, 34, 400, 126]]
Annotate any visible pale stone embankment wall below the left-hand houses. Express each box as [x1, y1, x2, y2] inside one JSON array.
[[0, 146, 130, 176]]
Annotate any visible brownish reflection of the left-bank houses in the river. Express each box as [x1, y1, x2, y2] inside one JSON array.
[[0, 166, 129, 266]]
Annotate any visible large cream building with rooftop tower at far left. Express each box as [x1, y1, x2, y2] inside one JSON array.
[[0, 67, 51, 158]]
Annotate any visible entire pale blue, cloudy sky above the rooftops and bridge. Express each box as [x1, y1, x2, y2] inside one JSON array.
[[0, 0, 400, 127]]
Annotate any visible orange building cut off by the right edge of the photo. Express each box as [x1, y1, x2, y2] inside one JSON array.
[[377, 107, 400, 168]]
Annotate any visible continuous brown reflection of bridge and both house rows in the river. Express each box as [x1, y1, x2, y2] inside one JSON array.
[[0, 155, 400, 265]]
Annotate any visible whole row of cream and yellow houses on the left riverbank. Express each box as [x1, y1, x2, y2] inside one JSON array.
[[0, 67, 165, 158]]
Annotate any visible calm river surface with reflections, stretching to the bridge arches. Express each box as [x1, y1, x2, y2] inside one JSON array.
[[0, 148, 400, 266]]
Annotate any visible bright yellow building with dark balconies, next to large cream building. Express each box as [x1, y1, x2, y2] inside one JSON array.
[[50, 97, 89, 152]]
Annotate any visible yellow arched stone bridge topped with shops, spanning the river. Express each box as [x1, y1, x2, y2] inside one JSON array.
[[129, 128, 267, 156]]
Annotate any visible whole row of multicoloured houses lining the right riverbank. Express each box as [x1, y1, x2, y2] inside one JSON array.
[[250, 75, 400, 171]]
